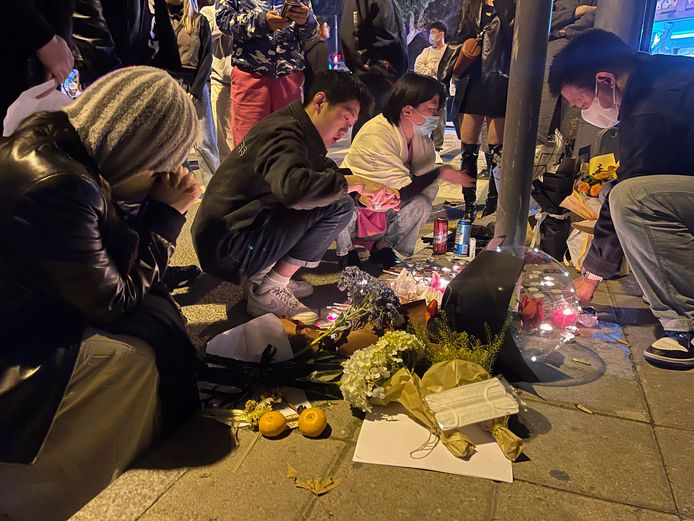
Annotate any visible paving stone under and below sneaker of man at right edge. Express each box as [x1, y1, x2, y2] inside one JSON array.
[[625, 326, 694, 431]]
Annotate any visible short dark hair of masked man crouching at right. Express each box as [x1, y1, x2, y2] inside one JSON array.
[[547, 29, 637, 96]]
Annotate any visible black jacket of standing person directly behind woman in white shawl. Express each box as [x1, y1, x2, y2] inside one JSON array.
[[340, 0, 408, 82]]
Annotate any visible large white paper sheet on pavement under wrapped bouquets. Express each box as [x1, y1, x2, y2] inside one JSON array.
[[352, 404, 513, 483]]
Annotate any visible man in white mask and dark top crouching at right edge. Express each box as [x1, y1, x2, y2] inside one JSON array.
[[549, 30, 694, 369]]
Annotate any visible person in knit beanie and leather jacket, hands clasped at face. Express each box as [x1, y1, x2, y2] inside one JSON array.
[[0, 67, 200, 520]]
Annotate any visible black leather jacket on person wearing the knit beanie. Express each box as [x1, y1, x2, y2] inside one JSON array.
[[0, 112, 185, 463]]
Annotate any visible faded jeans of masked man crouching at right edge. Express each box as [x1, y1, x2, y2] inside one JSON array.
[[609, 175, 694, 331]]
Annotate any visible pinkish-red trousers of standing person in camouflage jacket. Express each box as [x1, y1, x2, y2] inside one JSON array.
[[231, 67, 304, 145]]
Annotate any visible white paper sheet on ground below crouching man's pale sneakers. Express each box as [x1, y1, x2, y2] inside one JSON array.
[[207, 313, 294, 362]]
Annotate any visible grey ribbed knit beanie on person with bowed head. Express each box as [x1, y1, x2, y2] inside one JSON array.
[[63, 67, 198, 184]]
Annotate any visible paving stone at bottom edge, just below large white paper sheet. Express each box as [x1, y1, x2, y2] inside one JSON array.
[[307, 442, 494, 521]]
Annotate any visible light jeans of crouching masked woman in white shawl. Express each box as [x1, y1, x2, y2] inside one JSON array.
[[336, 189, 438, 257]]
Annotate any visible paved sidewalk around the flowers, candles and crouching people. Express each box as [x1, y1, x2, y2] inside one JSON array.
[[75, 131, 694, 521]]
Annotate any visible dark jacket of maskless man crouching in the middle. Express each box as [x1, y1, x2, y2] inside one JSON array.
[[193, 102, 351, 284]]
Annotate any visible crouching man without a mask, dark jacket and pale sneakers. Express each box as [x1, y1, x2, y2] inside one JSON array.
[[193, 71, 396, 323]]
